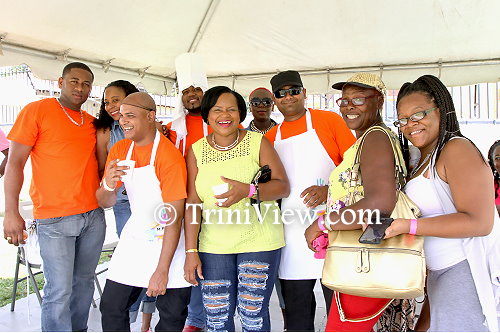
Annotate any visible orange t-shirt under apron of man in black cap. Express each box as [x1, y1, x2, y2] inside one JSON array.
[[265, 109, 356, 165]]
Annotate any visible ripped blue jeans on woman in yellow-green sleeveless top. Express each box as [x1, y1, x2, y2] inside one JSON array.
[[200, 249, 281, 332]]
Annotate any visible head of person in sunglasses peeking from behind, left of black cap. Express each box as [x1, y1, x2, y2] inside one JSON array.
[[246, 87, 277, 134]]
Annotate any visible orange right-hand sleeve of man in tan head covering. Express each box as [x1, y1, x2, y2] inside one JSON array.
[[156, 141, 187, 202]]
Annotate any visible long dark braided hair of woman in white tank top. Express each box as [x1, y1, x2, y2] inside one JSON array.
[[396, 75, 466, 167]]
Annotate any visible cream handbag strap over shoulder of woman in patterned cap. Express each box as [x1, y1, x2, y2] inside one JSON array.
[[348, 126, 406, 192]]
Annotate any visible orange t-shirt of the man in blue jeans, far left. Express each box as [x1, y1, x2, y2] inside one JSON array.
[[8, 98, 99, 219]]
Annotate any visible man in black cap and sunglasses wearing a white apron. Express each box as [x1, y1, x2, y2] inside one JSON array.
[[266, 71, 355, 331]]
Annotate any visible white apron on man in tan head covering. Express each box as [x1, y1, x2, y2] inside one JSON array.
[[107, 133, 190, 288]]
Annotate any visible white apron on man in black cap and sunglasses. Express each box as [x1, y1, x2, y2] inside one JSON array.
[[274, 110, 335, 280]]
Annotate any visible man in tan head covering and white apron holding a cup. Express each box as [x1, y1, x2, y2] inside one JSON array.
[[96, 92, 191, 331]]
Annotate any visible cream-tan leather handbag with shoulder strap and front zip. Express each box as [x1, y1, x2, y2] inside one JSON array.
[[321, 126, 426, 300]]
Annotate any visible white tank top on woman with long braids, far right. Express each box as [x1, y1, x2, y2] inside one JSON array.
[[405, 167, 466, 271]]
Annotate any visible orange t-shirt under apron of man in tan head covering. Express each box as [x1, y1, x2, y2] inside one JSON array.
[[106, 135, 187, 202]]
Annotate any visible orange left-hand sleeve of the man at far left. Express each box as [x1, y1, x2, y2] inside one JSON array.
[[7, 103, 40, 146]]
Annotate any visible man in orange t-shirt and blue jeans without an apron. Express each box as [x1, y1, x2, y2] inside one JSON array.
[[4, 62, 106, 331]]
